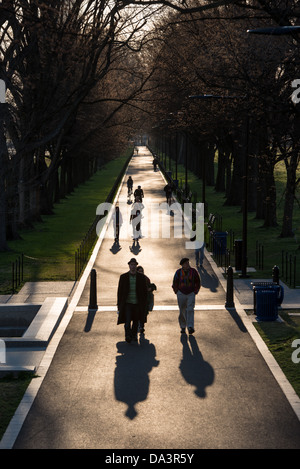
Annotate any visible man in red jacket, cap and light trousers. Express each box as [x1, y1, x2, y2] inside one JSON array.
[[172, 257, 201, 334]]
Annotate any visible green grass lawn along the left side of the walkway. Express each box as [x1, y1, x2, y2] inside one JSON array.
[[0, 149, 131, 294]]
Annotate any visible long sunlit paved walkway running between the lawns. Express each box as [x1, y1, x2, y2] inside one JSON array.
[[2, 148, 300, 449]]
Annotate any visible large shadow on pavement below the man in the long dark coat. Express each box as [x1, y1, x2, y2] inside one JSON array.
[[114, 336, 159, 420]]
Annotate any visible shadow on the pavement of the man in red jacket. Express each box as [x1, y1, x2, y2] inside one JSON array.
[[179, 334, 214, 398]]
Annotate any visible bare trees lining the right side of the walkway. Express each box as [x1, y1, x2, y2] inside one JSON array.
[[142, 0, 300, 237]]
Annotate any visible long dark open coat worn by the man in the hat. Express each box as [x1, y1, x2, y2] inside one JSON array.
[[118, 272, 148, 324]]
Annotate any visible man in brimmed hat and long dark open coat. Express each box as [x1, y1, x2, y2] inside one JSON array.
[[117, 258, 148, 343]]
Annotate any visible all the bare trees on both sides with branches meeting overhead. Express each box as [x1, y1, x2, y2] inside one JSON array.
[[0, 0, 300, 251]]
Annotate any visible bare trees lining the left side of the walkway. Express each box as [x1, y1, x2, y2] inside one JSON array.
[[0, 0, 168, 250]]
